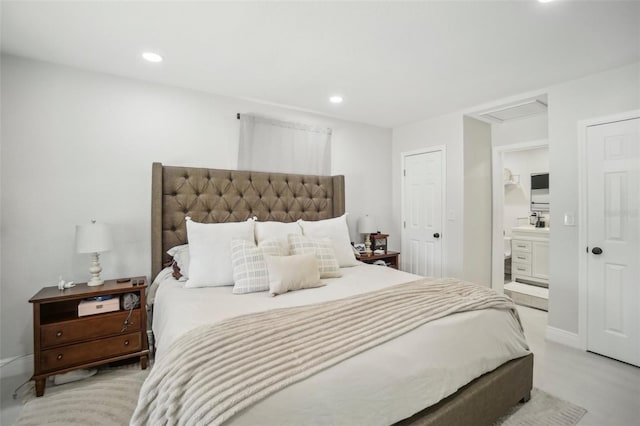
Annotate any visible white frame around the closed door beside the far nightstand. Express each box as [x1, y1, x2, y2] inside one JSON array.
[[400, 145, 447, 276]]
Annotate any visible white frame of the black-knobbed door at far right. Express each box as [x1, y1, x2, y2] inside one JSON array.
[[578, 109, 640, 351]]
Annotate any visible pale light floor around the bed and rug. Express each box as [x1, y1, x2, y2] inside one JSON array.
[[0, 306, 640, 426]]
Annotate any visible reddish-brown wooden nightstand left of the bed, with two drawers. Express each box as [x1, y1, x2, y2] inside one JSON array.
[[29, 277, 149, 396]]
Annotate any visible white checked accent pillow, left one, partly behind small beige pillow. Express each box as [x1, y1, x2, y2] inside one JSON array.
[[231, 238, 268, 294]]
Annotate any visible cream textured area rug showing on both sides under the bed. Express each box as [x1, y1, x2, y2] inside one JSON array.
[[16, 367, 587, 426]]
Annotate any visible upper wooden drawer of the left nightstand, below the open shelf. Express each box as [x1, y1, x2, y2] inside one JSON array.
[[40, 309, 140, 348]]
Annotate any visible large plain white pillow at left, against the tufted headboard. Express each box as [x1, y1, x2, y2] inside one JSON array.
[[185, 218, 254, 288]]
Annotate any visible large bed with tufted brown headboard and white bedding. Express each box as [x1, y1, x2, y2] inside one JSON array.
[[141, 163, 533, 425]]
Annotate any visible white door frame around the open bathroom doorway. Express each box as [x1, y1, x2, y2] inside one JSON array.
[[491, 139, 551, 293]]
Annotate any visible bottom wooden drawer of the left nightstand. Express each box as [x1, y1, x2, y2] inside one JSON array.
[[40, 332, 142, 372]]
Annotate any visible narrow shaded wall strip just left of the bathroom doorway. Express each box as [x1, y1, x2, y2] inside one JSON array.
[[462, 116, 492, 287]]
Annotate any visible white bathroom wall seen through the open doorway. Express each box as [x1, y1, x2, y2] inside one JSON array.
[[502, 148, 549, 236]]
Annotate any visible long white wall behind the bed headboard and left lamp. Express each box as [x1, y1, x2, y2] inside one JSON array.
[[0, 56, 392, 358]]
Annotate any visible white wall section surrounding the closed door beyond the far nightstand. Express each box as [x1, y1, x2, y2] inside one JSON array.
[[389, 114, 464, 277]]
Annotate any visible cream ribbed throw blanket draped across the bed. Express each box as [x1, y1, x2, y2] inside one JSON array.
[[131, 279, 517, 425]]
